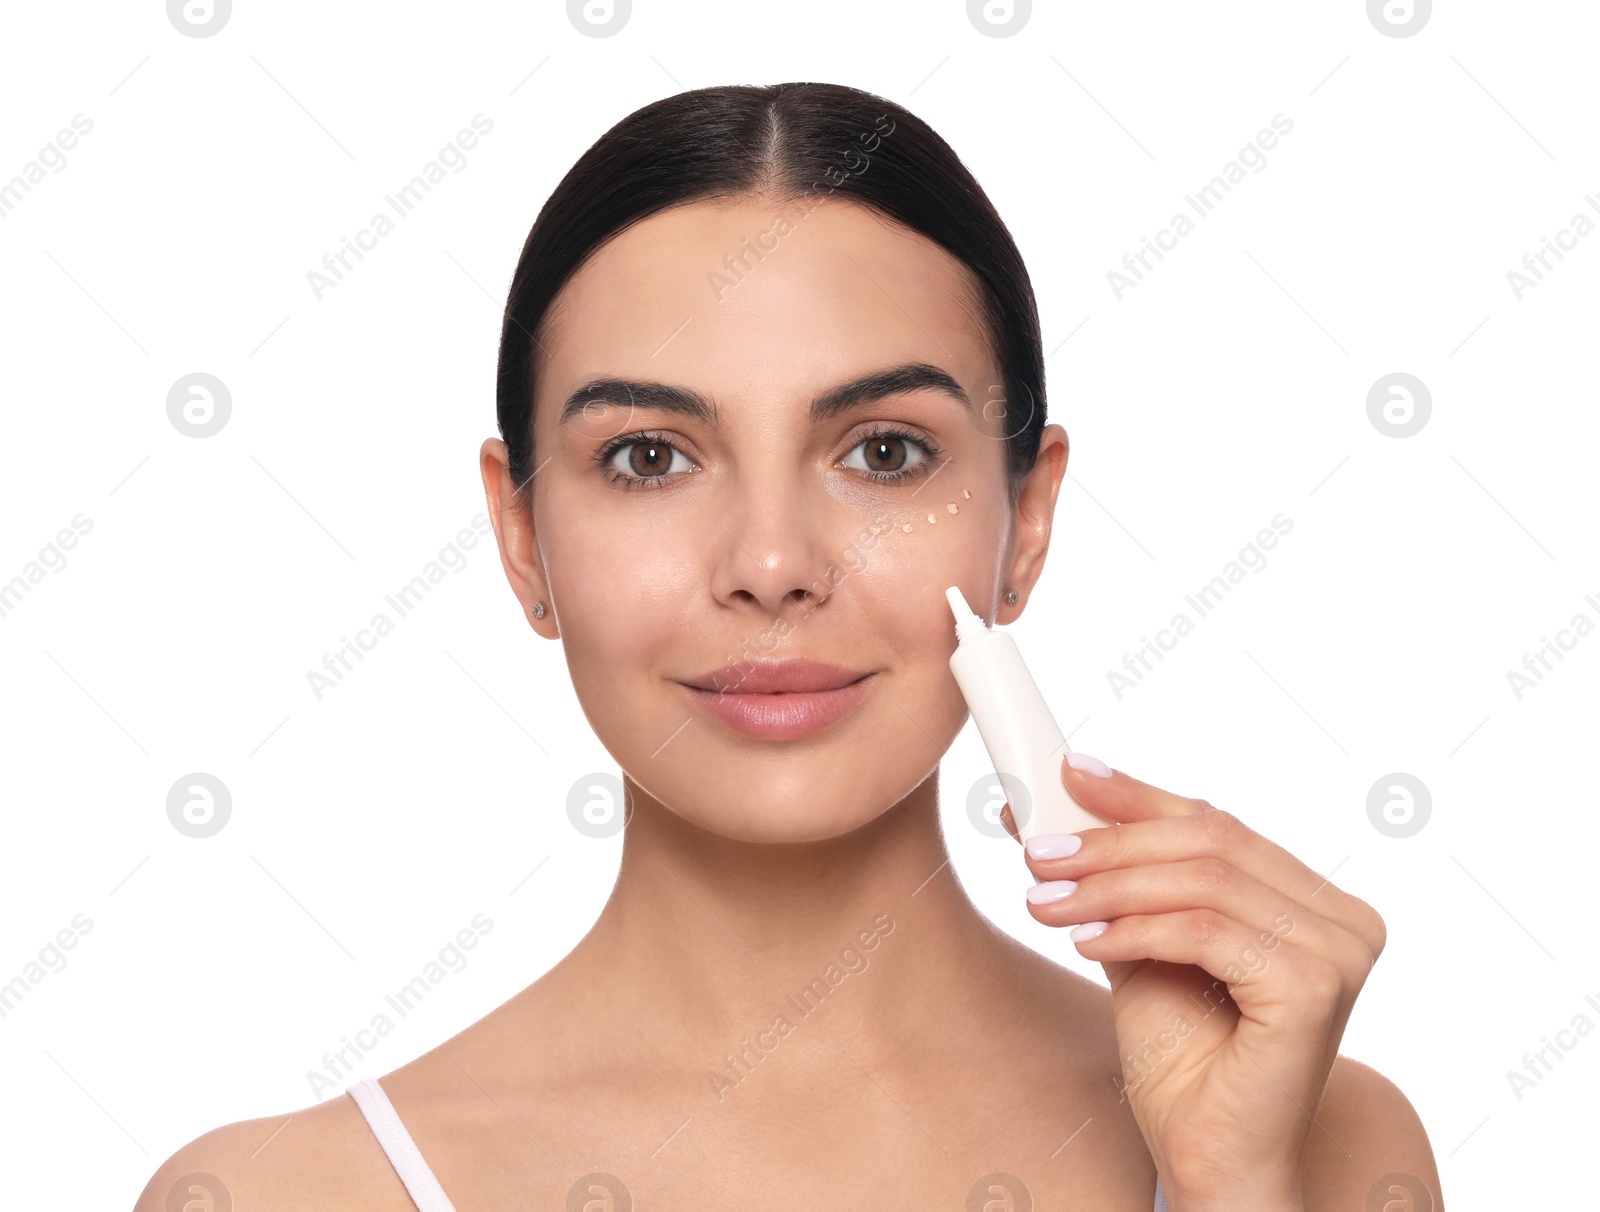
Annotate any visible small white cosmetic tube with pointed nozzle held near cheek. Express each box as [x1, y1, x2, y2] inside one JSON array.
[[944, 585, 1109, 841]]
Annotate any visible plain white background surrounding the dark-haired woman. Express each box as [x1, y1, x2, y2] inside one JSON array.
[[0, 0, 1600, 1207]]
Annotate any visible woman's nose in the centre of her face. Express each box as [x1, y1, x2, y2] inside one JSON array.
[[701, 478, 850, 617]]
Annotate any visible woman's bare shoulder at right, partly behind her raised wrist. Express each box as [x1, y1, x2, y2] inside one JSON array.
[[1301, 1055, 1445, 1212]]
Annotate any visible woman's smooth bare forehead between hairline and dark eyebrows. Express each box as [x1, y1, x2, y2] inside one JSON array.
[[538, 198, 997, 428]]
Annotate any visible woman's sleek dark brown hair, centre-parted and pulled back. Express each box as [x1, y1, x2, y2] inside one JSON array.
[[496, 83, 1045, 504]]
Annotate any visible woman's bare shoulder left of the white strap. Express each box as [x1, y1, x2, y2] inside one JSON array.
[[133, 1094, 414, 1212]]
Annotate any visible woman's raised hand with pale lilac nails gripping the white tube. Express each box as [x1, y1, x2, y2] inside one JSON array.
[[1003, 753, 1384, 1212]]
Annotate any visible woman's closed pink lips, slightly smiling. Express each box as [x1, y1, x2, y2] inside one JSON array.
[[680, 657, 875, 740]]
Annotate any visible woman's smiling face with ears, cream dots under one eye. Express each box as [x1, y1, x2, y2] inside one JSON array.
[[485, 198, 1064, 841]]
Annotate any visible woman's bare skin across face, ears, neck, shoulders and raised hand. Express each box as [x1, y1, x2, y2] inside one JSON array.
[[136, 198, 1442, 1212]]
